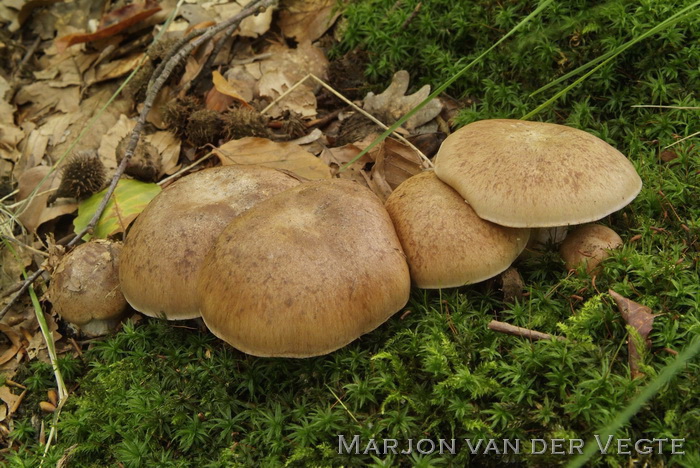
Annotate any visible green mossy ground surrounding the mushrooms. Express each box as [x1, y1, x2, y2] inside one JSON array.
[[8, 0, 700, 467]]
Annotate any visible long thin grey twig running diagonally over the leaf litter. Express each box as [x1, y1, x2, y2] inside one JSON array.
[[0, 0, 276, 319]]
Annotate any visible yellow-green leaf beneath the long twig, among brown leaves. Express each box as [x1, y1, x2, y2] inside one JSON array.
[[73, 179, 161, 240]]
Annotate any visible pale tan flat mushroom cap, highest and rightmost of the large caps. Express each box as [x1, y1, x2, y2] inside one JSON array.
[[435, 120, 642, 227]]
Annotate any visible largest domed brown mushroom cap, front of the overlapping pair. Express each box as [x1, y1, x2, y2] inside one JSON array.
[[198, 179, 411, 357]]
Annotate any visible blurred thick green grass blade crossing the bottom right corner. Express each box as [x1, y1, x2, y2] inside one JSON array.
[[566, 338, 700, 468]]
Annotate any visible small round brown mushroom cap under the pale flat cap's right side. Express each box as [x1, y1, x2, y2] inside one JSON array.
[[559, 224, 622, 273]]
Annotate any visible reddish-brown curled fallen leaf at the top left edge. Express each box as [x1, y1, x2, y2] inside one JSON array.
[[55, 0, 161, 52]]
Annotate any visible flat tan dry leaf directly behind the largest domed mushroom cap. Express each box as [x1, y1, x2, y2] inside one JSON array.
[[214, 137, 331, 180]]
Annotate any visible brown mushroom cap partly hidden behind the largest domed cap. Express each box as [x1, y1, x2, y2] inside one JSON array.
[[120, 166, 300, 320]]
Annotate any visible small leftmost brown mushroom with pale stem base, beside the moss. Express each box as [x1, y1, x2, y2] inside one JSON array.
[[48, 240, 126, 336]]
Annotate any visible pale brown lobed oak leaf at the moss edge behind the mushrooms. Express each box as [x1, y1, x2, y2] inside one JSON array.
[[363, 70, 442, 130]]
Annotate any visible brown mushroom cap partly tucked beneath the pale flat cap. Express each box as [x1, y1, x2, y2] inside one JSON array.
[[386, 171, 530, 289]]
